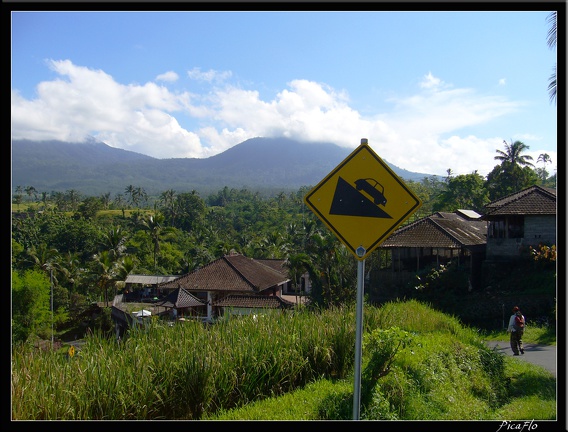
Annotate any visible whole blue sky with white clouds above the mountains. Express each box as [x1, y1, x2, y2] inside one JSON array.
[[11, 10, 557, 176]]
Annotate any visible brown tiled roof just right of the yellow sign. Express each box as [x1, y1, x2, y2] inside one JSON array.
[[380, 211, 487, 249]]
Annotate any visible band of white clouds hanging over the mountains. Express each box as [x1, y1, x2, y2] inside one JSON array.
[[11, 60, 556, 175]]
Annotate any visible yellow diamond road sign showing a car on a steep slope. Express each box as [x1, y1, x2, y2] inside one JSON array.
[[304, 139, 422, 261]]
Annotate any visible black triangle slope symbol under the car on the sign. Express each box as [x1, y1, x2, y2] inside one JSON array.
[[329, 177, 392, 219]]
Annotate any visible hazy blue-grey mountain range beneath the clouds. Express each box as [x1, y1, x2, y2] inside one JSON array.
[[12, 138, 430, 197]]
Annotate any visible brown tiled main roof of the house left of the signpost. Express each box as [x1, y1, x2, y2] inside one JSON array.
[[159, 254, 289, 294]]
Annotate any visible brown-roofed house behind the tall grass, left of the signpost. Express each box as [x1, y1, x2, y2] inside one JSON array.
[[158, 253, 294, 321]]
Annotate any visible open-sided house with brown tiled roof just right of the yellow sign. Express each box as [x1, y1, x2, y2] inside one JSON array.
[[378, 210, 487, 286]]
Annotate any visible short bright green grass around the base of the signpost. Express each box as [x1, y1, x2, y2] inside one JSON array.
[[204, 335, 557, 421]]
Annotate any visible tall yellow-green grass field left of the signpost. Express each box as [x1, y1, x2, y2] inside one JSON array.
[[12, 304, 354, 419]]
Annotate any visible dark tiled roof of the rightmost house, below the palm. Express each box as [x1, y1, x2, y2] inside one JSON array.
[[483, 186, 556, 219]]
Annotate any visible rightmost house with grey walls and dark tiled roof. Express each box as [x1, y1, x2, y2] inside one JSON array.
[[483, 186, 557, 262]]
